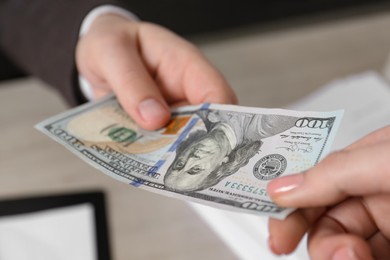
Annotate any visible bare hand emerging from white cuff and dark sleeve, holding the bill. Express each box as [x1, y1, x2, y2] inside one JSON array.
[[76, 14, 237, 130]]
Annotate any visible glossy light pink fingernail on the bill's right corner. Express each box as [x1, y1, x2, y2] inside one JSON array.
[[267, 174, 303, 196]]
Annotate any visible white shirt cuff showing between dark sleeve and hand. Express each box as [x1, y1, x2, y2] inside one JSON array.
[[79, 5, 139, 100]]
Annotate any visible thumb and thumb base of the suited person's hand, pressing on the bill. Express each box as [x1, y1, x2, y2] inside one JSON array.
[[78, 15, 170, 129]]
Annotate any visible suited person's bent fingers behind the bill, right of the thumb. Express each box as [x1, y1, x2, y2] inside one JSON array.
[[139, 23, 237, 104]]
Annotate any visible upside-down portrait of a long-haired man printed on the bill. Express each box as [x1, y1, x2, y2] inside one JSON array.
[[164, 110, 297, 193]]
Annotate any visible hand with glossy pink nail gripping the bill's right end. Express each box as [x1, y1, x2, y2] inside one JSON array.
[[268, 126, 390, 260]]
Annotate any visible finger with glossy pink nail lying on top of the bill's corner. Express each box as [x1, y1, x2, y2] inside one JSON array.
[[268, 137, 390, 207]]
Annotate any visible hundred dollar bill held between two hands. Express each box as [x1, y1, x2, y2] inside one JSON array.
[[36, 97, 342, 219]]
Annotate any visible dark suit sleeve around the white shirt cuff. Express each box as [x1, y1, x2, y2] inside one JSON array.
[[0, 0, 129, 105]]
